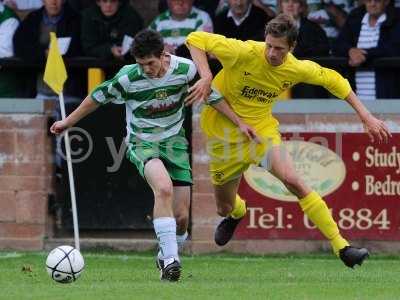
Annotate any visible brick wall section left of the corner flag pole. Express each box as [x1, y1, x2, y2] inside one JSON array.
[[0, 113, 53, 250]]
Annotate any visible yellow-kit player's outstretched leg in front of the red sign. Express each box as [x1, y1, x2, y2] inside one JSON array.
[[268, 146, 368, 267]]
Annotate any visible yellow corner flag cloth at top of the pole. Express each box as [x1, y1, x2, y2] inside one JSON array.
[[43, 32, 67, 95]]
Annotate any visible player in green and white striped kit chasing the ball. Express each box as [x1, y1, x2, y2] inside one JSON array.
[[50, 29, 257, 281]]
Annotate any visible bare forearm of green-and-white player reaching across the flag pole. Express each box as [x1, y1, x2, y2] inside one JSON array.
[[50, 95, 100, 134]]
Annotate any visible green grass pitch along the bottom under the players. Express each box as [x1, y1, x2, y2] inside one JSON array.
[[0, 252, 400, 300]]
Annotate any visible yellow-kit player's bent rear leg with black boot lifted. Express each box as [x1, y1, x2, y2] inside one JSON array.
[[214, 177, 246, 246]]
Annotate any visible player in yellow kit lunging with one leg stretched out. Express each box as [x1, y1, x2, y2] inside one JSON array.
[[186, 14, 391, 268]]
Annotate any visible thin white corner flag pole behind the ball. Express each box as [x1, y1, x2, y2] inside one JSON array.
[[59, 92, 80, 251]]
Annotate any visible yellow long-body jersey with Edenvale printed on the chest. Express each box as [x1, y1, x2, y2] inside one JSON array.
[[187, 31, 351, 142]]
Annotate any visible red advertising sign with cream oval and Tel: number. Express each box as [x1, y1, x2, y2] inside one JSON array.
[[235, 133, 400, 240]]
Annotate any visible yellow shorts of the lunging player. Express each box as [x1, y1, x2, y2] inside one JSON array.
[[207, 131, 281, 185]]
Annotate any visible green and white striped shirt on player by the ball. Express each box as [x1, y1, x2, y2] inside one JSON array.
[[91, 55, 222, 142]]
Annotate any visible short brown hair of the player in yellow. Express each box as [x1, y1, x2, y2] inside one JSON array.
[[265, 14, 299, 47]]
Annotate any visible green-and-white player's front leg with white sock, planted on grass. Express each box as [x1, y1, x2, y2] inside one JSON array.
[[144, 158, 181, 281]]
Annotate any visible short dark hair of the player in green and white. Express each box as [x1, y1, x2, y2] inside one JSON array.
[[131, 29, 164, 58]]
